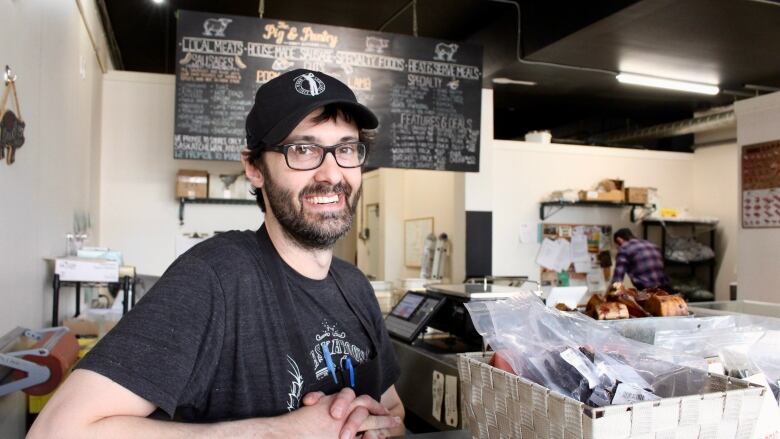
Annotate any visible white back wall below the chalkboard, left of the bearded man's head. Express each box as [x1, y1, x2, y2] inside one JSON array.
[[100, 71, 263, 275]]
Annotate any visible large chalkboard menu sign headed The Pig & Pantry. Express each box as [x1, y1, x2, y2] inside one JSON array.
[[174, 11, 482, 172]]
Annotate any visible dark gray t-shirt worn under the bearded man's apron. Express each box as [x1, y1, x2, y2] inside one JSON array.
[[78, 231, 400, 422]]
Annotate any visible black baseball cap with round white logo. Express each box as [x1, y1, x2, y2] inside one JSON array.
[[246, 69, 379, 149]]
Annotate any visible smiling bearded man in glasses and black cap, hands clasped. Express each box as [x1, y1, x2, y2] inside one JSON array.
[[30, 70, 404, 438]]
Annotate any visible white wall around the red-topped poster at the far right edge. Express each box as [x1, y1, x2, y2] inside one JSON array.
[[734, 93, 780, 303]]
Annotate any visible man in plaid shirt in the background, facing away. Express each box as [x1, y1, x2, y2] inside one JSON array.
[[612, 229, 669, 290]]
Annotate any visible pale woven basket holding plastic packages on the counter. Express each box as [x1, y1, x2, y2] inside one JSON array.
[[458, 353, 765, 439]]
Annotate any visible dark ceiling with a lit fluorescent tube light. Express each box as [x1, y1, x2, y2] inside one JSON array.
[[97, 0, 780, 151]]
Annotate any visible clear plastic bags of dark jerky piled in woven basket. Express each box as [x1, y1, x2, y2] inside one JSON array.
[[466, 294, 707, 407]]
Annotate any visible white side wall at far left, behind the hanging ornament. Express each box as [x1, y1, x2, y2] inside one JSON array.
[[0, 0, 109, 438]]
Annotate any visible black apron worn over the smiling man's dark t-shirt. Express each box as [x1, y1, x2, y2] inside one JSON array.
[[256, 224, 384, 410]]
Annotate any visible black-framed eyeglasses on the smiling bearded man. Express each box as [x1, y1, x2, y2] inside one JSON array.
[[266, 142, 368, 171]]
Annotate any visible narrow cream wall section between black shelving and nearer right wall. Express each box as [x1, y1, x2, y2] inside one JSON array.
[[693, 143, 739, 300]]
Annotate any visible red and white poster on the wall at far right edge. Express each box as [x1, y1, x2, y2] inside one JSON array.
[[742, 140, 780, 228]]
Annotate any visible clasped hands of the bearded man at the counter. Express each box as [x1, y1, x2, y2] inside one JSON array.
[[299, 388, 401, 439]]
